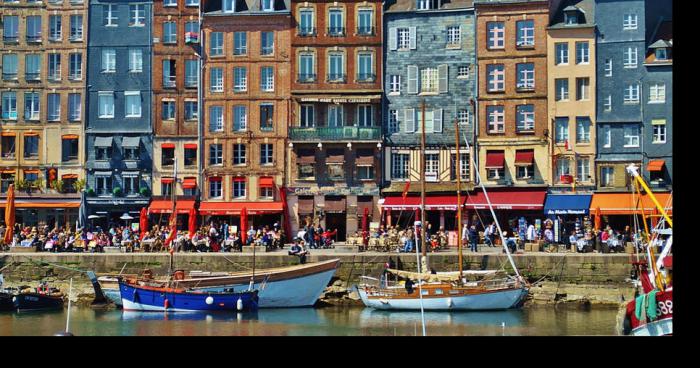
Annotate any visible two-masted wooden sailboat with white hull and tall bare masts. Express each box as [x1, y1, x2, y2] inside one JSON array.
[[357, 102, 528, 311]]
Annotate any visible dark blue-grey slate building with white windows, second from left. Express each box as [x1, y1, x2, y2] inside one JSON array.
[[85, 0, 153, 224]]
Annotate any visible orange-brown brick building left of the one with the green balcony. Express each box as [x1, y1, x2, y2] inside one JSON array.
[[199, 0, 292, 227]]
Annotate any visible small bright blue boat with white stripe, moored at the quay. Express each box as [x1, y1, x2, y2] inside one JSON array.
[[119, 280, 258, 312]]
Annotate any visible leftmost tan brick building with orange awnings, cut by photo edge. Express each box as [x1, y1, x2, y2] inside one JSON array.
[[0, 0, 87, 227]]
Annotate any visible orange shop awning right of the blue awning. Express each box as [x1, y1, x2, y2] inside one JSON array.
[[590, 193, 673, 215]]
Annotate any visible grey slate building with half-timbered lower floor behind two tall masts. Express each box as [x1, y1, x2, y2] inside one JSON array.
[[382, 0, 477, 231]]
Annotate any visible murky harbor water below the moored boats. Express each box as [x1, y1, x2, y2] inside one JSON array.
[[0, 306, 617, 336]]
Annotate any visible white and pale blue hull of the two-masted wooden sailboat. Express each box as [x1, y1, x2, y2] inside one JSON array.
[[358, 287, 528, 311]]
